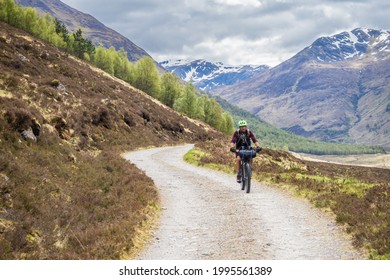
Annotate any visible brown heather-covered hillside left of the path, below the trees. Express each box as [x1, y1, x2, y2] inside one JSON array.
[[0, 22, 222, 259]]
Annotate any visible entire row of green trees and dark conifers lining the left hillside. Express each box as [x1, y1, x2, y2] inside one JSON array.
[[0, 0, 234, 134]]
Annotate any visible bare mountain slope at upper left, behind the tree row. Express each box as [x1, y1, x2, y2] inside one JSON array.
[[15, 0, 157, 62]]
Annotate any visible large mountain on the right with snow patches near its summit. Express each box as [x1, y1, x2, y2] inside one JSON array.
[[212, 28, 390, 148]]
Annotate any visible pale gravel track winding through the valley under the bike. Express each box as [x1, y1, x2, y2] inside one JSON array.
[[125, 145, 364, 260]]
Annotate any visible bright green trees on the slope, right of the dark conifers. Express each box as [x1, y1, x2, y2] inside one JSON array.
[[92, 45, 234, 134]]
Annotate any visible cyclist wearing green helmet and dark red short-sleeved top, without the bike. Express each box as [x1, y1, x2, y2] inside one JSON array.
[[230, 120, 261, 183]]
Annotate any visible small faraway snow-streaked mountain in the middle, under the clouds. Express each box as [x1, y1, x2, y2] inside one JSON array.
[[160, 59, 269, 91]]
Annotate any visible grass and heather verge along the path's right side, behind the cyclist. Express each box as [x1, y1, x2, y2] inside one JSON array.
[[185, 141, 390, 259]]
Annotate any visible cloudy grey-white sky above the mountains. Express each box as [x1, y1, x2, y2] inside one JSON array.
[[61, 0, 390, 66]]
